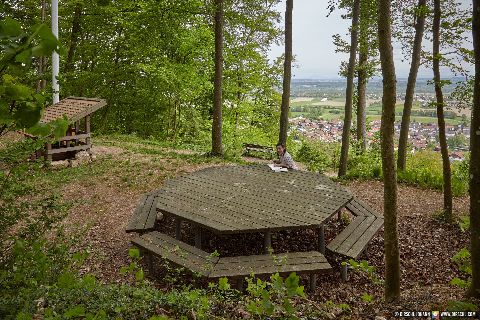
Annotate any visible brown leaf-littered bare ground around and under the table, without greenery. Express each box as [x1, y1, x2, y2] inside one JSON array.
[[11, 134, 476, 319]]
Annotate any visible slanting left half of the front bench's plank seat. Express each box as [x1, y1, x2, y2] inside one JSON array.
[[132, 231, 218, 276]]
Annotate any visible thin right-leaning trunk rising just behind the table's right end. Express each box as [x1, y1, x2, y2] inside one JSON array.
[[338, 0, 360, 177]]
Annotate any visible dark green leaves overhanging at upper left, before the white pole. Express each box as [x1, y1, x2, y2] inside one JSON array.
[[0, 17, 68, 137]]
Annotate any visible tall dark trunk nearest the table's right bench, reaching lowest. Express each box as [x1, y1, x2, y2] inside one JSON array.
[[378, 0, 400, 302]]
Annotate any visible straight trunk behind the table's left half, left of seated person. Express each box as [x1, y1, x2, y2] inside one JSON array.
[[212, 0, 223, 156]]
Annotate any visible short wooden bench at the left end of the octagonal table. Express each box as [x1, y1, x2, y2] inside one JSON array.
[[125, 191, 162, 233]]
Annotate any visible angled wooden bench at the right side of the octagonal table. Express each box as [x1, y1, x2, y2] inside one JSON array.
[[327, 199, 384, 280]]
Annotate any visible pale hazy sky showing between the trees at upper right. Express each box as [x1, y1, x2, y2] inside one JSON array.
[[270, 0, 474, 79]]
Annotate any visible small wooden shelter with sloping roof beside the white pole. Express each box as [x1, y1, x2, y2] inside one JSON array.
[[40, 97, 107, 161]]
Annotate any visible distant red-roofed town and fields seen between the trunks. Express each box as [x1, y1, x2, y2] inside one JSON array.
[[289, 81, 470, 161]]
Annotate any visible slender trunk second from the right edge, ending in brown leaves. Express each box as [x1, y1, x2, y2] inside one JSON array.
[[433, 0, 452, 221]]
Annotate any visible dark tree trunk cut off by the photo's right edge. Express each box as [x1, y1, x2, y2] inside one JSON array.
[[469, 0, 480, 298]]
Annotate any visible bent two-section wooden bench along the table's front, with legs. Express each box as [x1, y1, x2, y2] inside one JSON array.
[[132, 231, 332, 291]]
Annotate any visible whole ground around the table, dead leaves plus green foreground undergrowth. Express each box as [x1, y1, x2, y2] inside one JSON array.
[[0, 137, 471, 319]]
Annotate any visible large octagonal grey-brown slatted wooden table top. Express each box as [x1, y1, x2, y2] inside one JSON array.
[[157, 165, 353, 233]]
